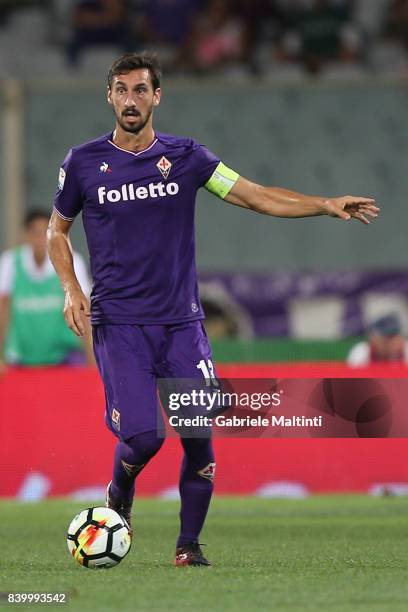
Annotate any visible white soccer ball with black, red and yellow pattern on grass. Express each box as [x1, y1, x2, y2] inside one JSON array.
[[67, 508, 131, 569]]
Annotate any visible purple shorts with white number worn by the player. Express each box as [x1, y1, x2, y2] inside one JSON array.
[[93, 321, 213, 440]]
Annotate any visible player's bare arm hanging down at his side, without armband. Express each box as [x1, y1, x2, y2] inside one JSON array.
[[47, 210, 91, 336]]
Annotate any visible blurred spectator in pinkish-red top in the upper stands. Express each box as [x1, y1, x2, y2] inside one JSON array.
[[192, 0, 245, 72]]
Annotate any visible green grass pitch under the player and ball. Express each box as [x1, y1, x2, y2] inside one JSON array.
[[0, 496, 408, 612]]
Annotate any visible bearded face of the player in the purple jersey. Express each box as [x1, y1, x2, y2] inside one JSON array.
[[108, 68, 161, 134]]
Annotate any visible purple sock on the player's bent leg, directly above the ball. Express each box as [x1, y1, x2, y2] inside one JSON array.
[[111, 431, 163, 503]]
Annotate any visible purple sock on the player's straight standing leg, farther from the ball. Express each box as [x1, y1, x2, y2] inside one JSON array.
[[177, 438, 215, 546]]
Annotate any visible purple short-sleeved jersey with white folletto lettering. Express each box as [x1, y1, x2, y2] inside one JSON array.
[[54, 132, 220, 324]]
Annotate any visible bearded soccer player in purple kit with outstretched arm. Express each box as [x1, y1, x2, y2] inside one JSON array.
[[48, 54, 379, 566]]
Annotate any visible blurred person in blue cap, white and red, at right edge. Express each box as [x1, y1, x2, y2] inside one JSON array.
[[347, 314, 408, 367]]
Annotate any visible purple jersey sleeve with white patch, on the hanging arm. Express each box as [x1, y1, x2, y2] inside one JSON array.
[[54, 149, 82, 221]]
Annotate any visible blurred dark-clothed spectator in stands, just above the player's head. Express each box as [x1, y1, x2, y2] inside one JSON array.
[[67, 0, 129, 65]]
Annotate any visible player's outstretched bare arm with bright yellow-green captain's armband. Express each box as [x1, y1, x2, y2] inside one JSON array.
[[205, 163, 380, 224]]
